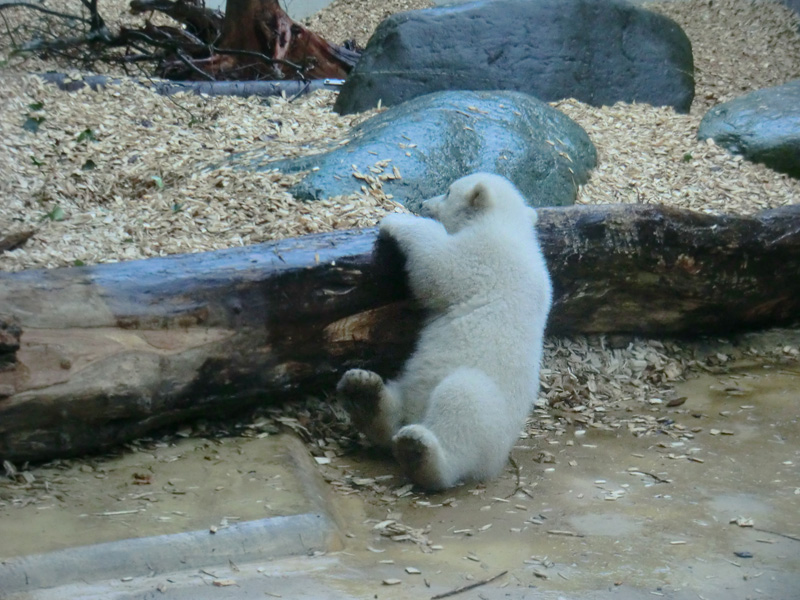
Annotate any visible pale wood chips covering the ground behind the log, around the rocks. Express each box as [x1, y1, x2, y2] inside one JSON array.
[[0, 0, 800, 271]]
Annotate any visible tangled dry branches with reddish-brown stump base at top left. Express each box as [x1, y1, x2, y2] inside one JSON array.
[[0, 0, 360, 81]]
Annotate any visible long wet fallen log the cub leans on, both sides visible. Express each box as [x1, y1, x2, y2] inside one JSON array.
[[0, 205, 800, 461]]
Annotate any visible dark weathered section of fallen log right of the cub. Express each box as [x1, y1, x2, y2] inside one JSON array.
[[539, 205, 800, 336]]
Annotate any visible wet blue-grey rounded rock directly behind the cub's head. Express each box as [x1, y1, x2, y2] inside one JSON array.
[[230, 91, 596, 212]]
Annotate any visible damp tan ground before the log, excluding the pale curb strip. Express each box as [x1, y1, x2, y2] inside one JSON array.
[[0, 330, 800, 600]]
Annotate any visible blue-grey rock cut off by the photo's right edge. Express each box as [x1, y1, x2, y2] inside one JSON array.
[[697, 79, 800, 177]]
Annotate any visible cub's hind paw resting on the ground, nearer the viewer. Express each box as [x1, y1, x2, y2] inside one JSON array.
[[392, 425, 455, 490]]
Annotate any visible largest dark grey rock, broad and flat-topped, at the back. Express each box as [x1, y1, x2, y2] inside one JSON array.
[[336, 0, 694, 114]]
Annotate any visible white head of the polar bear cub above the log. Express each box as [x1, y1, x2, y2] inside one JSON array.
[[420, 173, 536, 234]]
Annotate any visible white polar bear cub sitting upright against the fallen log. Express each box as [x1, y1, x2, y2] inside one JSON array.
[[337, 173, 552, 490]]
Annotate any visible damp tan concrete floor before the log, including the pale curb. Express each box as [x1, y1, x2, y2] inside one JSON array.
[[0, 354, 800, 600]]
